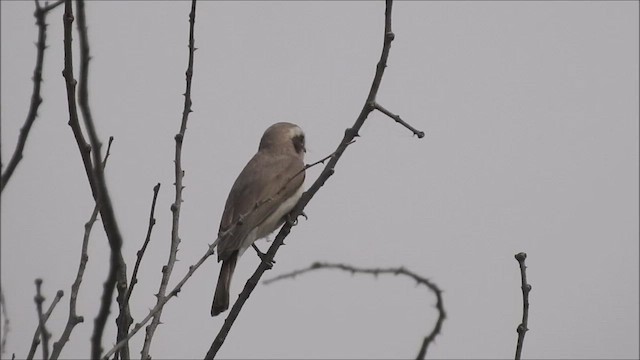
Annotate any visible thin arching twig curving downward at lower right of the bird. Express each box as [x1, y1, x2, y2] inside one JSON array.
[[262, 262, 446, 359]]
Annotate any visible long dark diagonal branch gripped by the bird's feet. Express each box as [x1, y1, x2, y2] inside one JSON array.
[[205, 0, 424, 359]]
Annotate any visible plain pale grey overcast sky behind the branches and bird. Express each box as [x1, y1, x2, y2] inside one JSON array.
[[0, 1, 640, 358]]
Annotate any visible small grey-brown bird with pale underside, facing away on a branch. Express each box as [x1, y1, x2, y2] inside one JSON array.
[[211, 122, 307, 316]]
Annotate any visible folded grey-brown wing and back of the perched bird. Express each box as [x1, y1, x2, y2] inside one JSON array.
[[218, 151, 305, 261]]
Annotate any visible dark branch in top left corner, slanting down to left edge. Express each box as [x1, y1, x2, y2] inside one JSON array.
[[0, 0, 62, 193]]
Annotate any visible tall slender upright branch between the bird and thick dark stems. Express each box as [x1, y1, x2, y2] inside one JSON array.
[[142, 0, 196, 359]]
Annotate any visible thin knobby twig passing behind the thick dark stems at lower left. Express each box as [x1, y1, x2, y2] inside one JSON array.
[[51, 136, 113, 360]]
